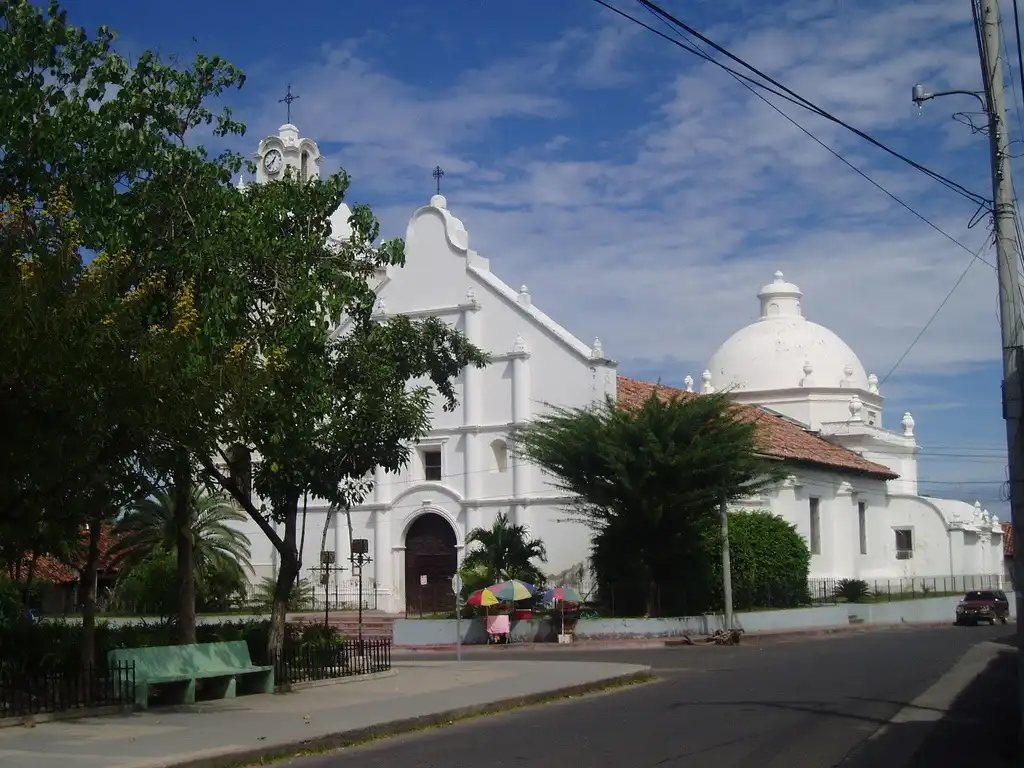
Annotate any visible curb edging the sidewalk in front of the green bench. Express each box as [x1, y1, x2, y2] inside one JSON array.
[[154, 667, 654, 768]]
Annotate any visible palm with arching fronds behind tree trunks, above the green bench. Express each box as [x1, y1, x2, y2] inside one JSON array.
[[110, 487, 252, 583]]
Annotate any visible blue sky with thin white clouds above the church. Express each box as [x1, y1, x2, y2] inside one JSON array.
[[66, 0, 1024, 516]]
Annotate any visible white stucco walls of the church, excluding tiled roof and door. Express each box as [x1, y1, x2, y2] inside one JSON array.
[[228, 134, 1002, 611]]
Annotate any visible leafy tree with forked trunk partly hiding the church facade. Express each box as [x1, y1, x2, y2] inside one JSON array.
[[204, 173, 486, 654]]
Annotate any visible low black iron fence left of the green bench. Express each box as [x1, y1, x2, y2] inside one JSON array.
[[0, 662, 135, 719]]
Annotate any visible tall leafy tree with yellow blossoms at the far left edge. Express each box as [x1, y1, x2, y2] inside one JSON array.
[[0, 0, 248, 645]]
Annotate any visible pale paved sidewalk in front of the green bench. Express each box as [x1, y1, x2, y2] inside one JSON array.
[[0, 659, 650, 768]]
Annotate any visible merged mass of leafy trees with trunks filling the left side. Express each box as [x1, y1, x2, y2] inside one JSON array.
[[0, 0, 485, 655]]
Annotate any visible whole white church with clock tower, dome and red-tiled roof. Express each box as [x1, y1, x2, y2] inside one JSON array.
[[228, 124, 1004, 612]]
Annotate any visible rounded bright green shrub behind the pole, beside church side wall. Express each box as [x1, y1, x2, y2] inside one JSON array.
[[708, 510, 811, 609]]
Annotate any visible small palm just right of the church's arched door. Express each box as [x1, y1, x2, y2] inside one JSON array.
[[462, 512, 548, 586]]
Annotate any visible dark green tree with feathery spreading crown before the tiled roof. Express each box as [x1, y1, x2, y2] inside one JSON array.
[[515, 389, 781, 615]]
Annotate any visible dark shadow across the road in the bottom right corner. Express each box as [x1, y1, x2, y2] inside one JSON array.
[[843, 637, 1024, 768]]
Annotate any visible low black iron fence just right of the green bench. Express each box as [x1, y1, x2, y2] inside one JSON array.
[[273, 638, 391, 687]]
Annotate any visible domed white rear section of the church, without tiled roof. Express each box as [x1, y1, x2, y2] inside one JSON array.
[[703, 272, 1002, 580]]
